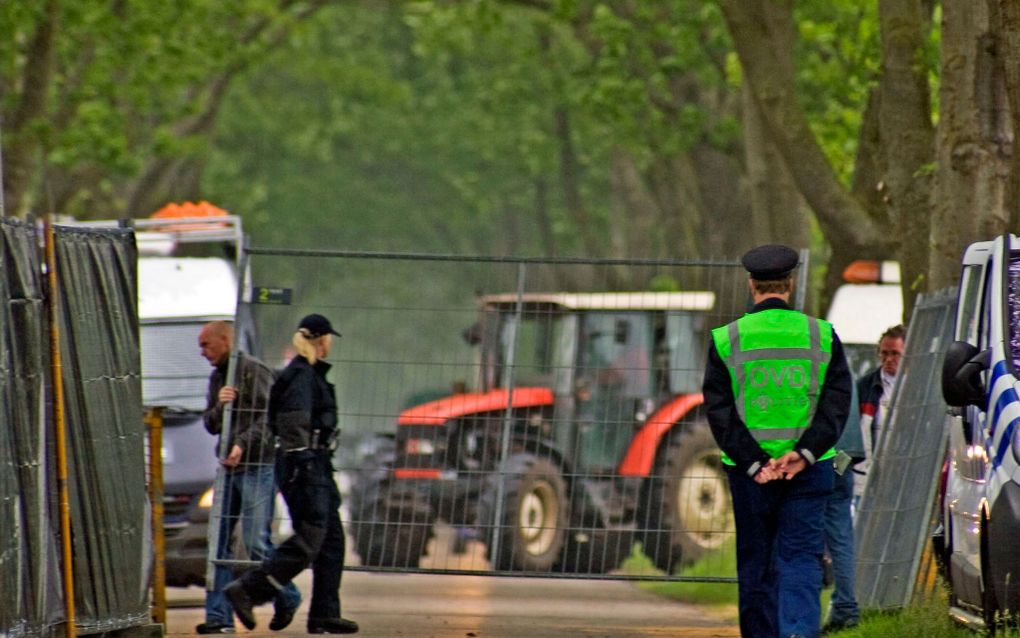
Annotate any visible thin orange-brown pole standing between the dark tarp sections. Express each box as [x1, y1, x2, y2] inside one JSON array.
[[43, 215, 78, 638]]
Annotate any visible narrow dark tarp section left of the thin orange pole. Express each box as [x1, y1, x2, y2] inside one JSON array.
[[0, 220, 63, 635]]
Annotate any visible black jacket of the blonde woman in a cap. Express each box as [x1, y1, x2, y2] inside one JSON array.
[[269, 355, 337, 451]]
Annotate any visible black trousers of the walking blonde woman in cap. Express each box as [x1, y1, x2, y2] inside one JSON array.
[[243, 450, 345, 619]]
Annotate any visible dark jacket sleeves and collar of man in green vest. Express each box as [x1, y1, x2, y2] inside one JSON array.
[[703, 297, 853, 473]]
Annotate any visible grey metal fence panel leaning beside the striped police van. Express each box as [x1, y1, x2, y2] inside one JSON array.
[[856, 291, 956, 608]]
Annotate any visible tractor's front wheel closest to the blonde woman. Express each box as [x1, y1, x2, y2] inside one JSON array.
[[349, 434, 434, 568]]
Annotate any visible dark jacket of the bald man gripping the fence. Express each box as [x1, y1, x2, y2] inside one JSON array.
[[202, 352, 274, 469]]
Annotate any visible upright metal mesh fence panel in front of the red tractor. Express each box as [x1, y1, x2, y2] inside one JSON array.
[[213, 248, 811, 582]]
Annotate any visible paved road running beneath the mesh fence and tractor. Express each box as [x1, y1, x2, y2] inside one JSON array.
[[166, 571, 740, 638]]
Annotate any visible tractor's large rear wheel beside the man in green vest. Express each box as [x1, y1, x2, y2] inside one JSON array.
[[638, 423, 735, 573]]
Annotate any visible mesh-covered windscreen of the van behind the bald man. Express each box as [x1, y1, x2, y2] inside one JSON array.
[[141, 322, 212, 411]]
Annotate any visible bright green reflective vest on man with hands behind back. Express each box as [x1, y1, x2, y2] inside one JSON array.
[[712, 308, 835, 465]]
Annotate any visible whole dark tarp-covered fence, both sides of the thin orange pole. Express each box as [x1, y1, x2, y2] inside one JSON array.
[[0, 219, 151, 636]]
